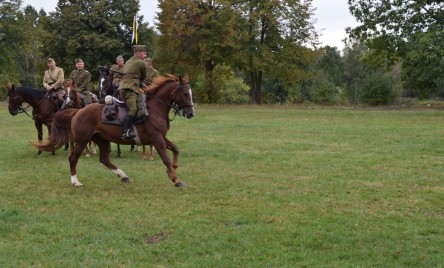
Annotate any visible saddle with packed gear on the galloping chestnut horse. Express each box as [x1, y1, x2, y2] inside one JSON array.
[[102, 95, 148, 126]]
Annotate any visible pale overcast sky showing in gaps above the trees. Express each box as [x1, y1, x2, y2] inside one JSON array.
[[23, 0, 357, 50]]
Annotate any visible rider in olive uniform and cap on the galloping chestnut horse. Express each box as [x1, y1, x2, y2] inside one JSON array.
[[119, 45, 146, 140]]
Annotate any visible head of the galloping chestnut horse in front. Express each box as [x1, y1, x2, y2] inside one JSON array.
[[172, 75, 194, 119]]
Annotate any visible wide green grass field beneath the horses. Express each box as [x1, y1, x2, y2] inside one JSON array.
[[0, 103, 444, 267]]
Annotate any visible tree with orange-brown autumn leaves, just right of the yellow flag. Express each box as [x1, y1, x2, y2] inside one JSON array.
[[158, 0, 238, 103]]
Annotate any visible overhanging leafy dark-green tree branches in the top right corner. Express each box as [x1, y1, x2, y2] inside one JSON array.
[[347, 0, 444, 96]]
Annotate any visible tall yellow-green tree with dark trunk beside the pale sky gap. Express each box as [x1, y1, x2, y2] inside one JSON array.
[[237, 0, 318, 104]]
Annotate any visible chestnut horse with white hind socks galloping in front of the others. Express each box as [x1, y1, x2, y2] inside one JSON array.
[[32, 76, 194, 187]]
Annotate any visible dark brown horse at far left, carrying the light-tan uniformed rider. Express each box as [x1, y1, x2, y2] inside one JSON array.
[[6, 85, 57, 154]]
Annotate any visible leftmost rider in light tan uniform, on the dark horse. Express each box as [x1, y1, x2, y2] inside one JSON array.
[[43, 58, 65, 107]]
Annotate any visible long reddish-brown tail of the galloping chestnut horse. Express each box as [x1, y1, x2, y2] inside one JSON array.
[[31, 108, 80, 152]]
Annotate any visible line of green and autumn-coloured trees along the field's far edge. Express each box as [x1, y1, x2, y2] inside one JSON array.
[[0, 0, 444, 105]]
